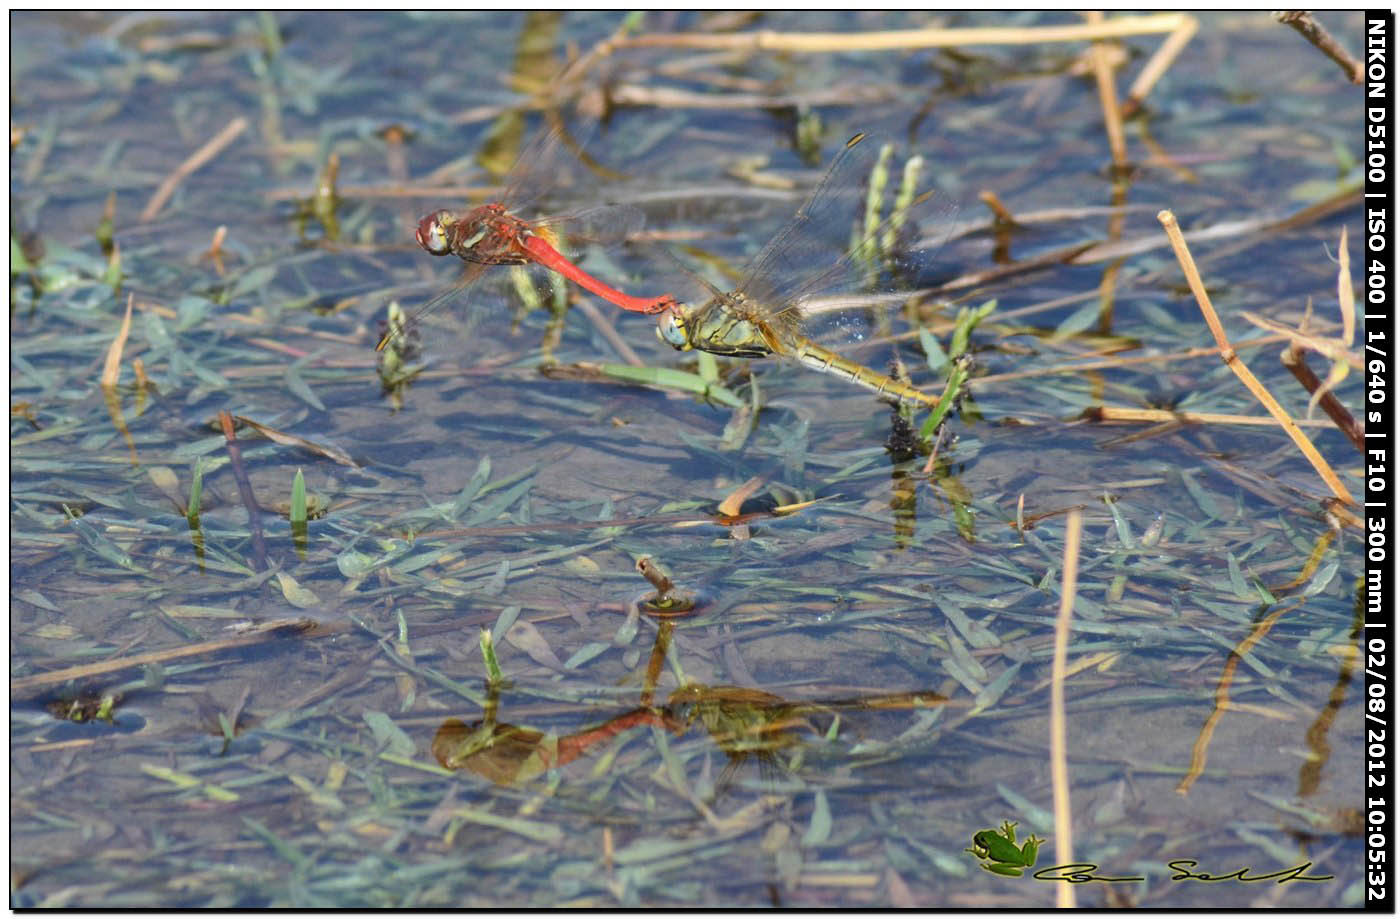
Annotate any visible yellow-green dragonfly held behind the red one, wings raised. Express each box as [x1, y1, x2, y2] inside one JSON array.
[[657, 134, 938, 408]]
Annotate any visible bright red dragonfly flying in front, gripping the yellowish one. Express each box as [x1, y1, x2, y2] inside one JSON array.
[[375, 129, 676, 350]]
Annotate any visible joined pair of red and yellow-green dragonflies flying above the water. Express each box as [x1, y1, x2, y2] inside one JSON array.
[[378, 133, 938, 408]]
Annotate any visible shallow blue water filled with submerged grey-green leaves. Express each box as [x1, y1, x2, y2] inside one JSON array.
[[10, 13, 1362, 906]]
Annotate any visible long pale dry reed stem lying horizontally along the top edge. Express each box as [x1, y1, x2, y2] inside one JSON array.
[[613, 13, 1191, 56]]
